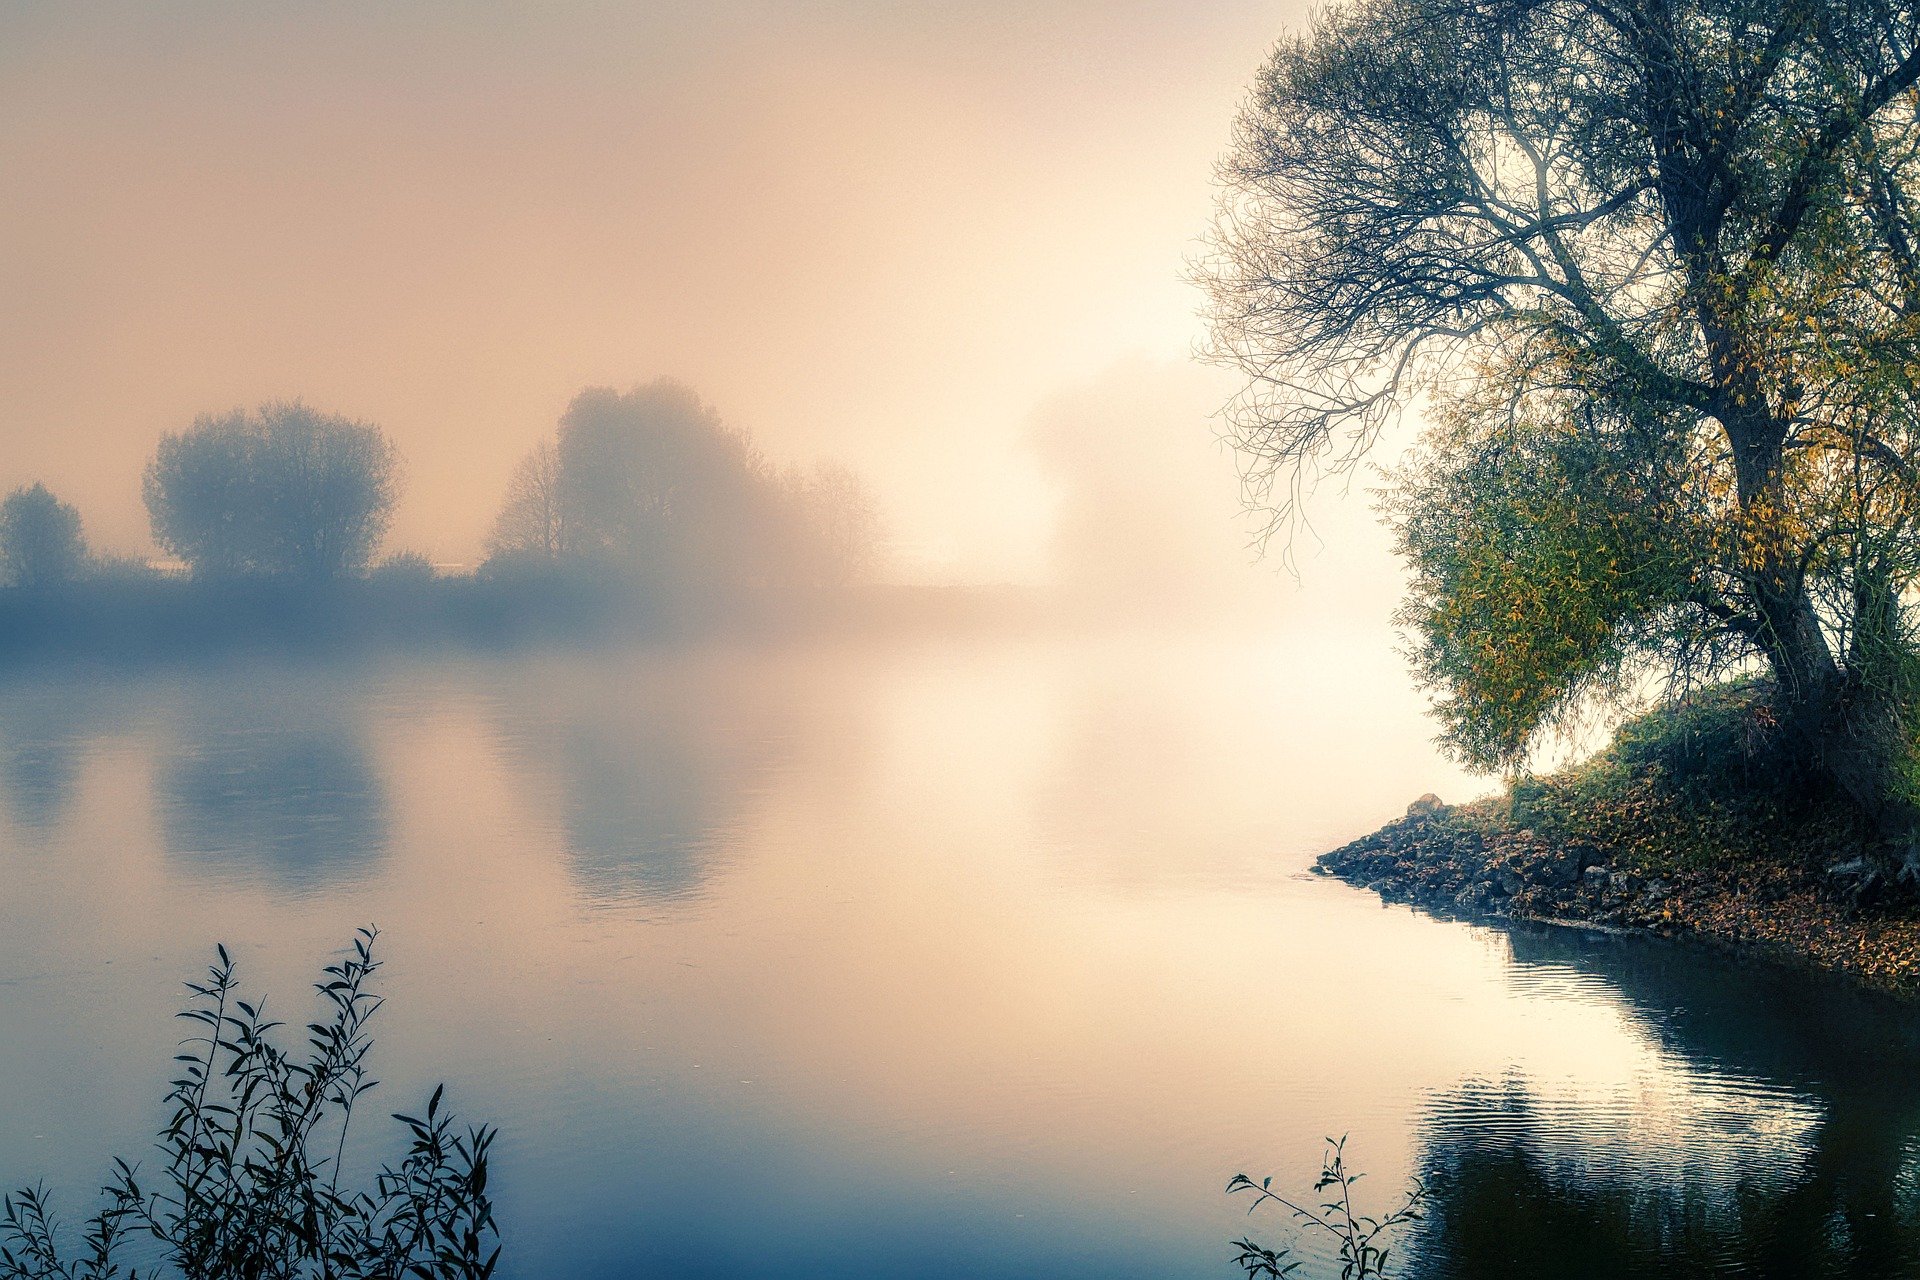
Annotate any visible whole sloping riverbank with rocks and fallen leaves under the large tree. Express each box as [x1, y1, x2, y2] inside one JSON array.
[[1315, 685, 1920, 996]]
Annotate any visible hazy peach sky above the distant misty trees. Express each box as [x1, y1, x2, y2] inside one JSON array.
[[0, 0, 1302, 576]]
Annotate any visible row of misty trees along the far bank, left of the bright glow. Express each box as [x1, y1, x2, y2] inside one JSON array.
[[0, 380, 879, 614]]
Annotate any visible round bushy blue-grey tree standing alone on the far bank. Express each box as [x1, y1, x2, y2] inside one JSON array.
[[142, 401, 399, 581]]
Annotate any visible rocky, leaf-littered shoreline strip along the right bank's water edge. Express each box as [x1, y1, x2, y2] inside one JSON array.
[[1313, 794, 1920, 996]]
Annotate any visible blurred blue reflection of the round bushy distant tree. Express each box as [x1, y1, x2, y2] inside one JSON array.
[[156, 689, 388, 890]]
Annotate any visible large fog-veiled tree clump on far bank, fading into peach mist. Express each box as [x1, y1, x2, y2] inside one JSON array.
[[488, 378, 879, 589]]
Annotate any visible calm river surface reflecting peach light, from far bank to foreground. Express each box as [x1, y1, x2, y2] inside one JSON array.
[[0, 635, 1920, 1278]]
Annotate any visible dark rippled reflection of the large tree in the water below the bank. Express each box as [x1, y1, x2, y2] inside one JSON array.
[[1413, 929, 1920, 1280]]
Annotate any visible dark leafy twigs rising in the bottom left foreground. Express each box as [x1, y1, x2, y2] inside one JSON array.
[[0, 929, 499, 1280]]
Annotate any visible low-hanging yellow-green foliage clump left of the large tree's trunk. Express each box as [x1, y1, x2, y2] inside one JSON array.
[[1394, 412, 1697, 770]]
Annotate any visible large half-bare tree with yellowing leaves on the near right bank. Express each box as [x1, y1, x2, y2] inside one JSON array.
[[1200, 0, 1920, 831]]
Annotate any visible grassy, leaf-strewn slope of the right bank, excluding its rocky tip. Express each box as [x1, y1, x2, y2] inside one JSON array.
[[1442, 681, 1920, 996]]
